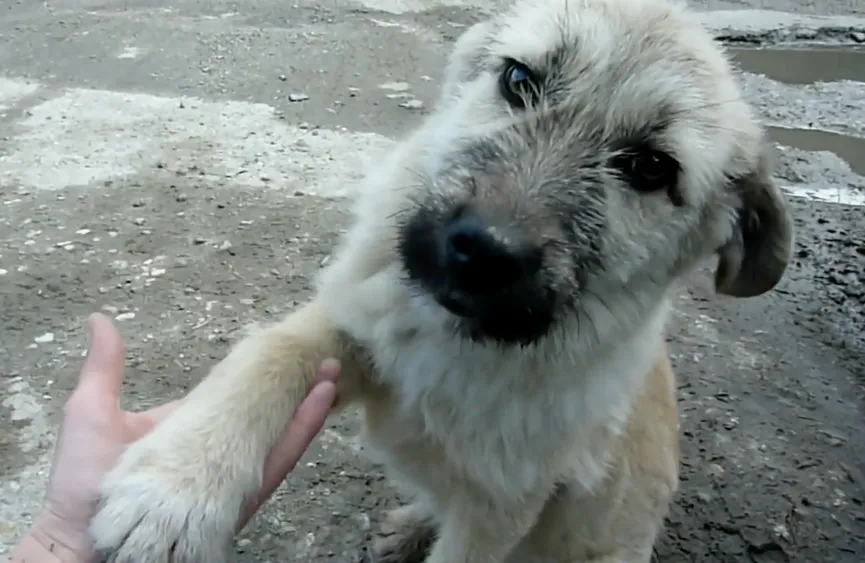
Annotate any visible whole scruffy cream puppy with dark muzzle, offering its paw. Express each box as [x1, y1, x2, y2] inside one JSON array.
[[86, 0, 793, 563]]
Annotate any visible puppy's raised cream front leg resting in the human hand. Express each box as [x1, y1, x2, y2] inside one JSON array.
[[91, 301, 363, 563]]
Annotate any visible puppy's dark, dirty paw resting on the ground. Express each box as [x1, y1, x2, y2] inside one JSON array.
[[366, 504, 438, 563]]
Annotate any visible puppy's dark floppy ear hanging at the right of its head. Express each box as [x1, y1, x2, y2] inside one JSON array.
[[715, 142, 793, 297]]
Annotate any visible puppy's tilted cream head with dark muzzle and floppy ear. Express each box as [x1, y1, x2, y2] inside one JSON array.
[[399, 0, 792, 344]]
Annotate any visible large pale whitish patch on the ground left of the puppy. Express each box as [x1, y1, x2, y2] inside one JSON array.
[[0, 81, 391, 196]]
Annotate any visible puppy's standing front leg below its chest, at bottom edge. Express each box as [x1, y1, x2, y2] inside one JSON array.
[[425, 492, 548, 563]]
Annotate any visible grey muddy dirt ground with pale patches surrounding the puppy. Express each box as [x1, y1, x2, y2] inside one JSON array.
[[0, 2, 865, 563]]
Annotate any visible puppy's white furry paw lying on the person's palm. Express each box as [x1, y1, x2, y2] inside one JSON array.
[[90, 451, 242, 563]]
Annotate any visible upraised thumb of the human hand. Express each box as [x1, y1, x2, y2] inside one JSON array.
[[76, 313, 126, 399]]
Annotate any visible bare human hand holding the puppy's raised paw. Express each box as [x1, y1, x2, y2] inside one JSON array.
[[13, 314, 340, 561]]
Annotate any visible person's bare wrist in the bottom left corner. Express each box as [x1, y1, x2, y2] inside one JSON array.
[[9, 513, 92, 563]]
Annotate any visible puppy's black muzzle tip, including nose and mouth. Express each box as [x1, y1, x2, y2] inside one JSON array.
[[399, 206, 557, 344]]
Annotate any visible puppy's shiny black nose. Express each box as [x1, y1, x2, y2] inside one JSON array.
[[444, 212, 540, 295]]
